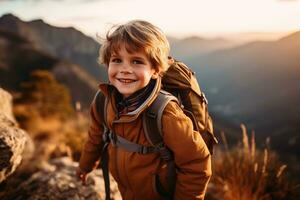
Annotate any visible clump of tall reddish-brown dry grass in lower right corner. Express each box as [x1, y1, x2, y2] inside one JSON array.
[[207, 125, 299, 200]]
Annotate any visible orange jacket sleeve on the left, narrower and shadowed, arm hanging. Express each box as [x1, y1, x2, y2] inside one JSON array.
[[79, 94, 104, 172]]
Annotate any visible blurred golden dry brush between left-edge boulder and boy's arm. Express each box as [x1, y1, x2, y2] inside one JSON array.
[[0, 104, 89, 199]]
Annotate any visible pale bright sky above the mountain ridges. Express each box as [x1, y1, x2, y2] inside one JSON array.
[[0, 0, 300, 39]]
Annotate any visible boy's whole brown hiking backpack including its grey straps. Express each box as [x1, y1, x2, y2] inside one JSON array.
[[95, 59, 218, 199]]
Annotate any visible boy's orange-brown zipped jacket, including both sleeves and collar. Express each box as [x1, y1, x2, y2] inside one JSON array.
[[79, 79, 211, 200]]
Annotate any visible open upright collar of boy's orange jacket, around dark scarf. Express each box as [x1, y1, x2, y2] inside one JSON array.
[[99, 77, 161, 123]]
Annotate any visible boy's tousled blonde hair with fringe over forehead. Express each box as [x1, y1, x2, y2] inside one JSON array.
[[98, 20, 170, 74]]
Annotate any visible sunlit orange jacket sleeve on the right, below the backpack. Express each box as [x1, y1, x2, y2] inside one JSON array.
[[162, 102, 212, 200]]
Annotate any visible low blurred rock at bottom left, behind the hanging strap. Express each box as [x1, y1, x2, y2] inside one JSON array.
[[4, 157, 121, 200]]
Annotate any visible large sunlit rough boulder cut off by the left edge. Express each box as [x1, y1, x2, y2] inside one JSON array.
[[0, 88, 30, 183]]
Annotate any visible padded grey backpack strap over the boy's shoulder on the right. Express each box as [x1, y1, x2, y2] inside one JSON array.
[[143, 90, 178, 146]]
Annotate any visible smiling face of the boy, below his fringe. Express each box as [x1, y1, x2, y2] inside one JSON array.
[[108, 45, 158, 97]]
